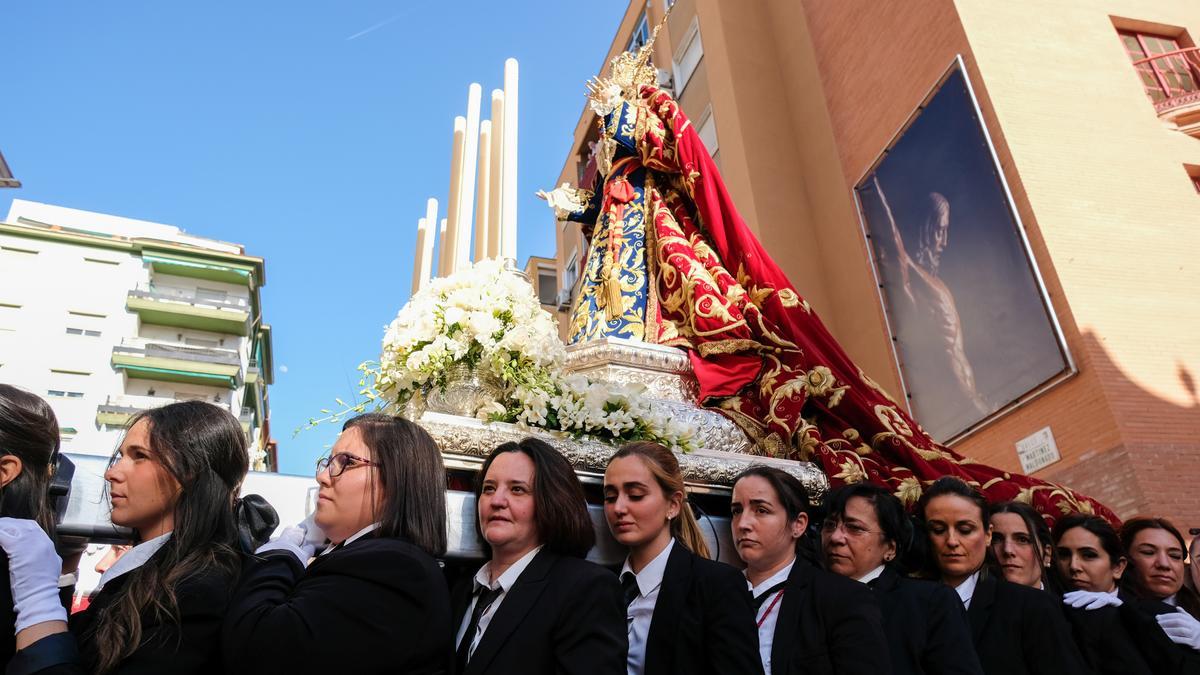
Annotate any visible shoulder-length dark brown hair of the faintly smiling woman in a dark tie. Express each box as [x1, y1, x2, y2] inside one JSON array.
[[475, 436, 596, 557]]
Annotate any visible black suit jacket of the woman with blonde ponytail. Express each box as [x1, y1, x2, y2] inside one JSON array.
[[644, 542, 762, 675]]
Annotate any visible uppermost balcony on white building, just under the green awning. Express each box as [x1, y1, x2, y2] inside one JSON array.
[[125, 283, 250, 335]]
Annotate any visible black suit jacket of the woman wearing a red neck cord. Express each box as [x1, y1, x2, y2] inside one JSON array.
[[770, 558, 892, 675]]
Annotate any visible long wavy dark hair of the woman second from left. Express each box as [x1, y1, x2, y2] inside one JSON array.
[[90, 401, 250, 673]]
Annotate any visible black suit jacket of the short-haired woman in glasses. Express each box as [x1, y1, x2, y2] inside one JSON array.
[[869, 567, 983, 675]]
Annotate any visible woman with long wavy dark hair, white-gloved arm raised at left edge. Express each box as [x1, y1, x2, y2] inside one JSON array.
[[0, 401, 250, 675]]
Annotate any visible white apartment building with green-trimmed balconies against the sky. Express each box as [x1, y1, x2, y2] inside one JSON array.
[[0, 199, 276, 470]]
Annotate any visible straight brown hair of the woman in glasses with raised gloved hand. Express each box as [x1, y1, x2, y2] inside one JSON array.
[[342, 412, 446, 556]]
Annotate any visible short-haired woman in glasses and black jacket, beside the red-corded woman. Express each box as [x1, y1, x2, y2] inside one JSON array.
[[821, 483, 983, 675]]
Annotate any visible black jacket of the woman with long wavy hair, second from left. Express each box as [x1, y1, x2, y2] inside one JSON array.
[[7, 554, 236, 675]]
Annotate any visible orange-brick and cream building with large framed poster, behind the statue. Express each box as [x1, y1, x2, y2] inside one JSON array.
[[556, 0, 1200, 526]]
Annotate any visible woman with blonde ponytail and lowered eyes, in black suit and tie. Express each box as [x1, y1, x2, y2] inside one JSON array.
[[604, 441, 762, 675]]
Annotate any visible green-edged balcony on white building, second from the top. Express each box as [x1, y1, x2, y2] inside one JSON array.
[[113, 338, 242, 389]]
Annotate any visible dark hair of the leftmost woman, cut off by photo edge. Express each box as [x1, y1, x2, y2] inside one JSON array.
[[0, 384, 60, 537]]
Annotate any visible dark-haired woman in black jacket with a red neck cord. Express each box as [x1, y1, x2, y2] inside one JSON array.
[[730, 465, 892, 675]]
